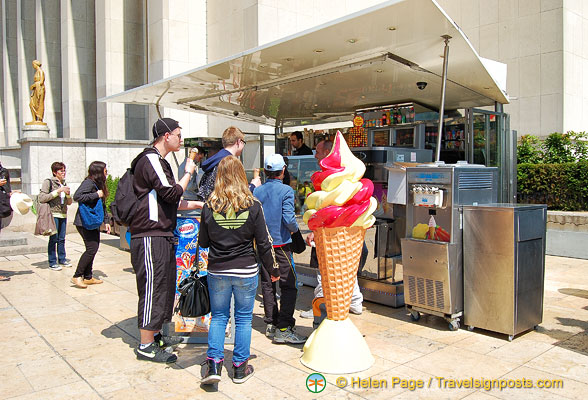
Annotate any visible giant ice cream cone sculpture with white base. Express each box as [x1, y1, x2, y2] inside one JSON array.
[[301, 132, 377, 373]]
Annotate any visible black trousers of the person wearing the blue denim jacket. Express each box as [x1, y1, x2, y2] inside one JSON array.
[[260, 244, 298, 329]]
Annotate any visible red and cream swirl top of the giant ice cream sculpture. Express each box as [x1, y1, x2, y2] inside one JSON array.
[[303, 132, 377, 230]]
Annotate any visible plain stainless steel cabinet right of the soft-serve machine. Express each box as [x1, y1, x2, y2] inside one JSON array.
[[463, 204, 547, 340]]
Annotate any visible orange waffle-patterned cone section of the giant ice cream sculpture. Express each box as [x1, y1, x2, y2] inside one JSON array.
[[314, 226, 365, 321]]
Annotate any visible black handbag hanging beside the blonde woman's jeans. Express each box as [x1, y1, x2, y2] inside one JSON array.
[[174, 269, 210, 318]]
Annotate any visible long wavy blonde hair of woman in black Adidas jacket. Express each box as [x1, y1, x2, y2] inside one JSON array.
[[207, 156, 253, 213]]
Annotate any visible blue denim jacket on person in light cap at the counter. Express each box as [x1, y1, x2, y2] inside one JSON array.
[[253, 179, 298, 246]]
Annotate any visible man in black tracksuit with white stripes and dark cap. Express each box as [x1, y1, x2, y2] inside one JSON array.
[[130, 118, 202, 363]]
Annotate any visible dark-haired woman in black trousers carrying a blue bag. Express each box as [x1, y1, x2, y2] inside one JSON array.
[[71, 161, 110, 289]]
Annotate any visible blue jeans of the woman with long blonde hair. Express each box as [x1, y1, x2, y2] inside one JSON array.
[[206, 274, 258, 365]]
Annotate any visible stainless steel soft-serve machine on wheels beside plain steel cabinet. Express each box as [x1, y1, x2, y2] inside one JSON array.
[[402, 163, 498, 330]]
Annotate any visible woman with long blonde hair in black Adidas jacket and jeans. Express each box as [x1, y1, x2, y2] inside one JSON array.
[[198, 155, 279, 384]]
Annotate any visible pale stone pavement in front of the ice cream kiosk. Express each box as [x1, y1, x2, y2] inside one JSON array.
[[0, 234, 588, 400]]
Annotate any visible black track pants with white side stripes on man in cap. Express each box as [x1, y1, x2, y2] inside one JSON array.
[[131, 236, 177, 331]]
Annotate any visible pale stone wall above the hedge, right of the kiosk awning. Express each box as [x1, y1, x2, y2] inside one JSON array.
[[438, 0, 568, 136]]
